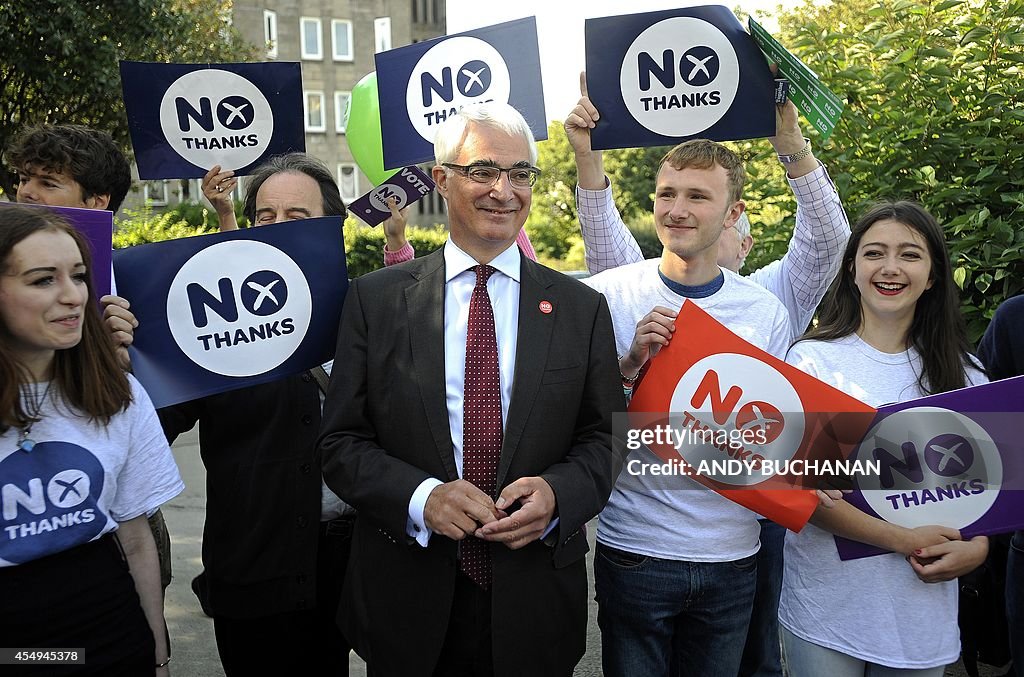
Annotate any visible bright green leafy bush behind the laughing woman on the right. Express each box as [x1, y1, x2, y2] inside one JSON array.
[[780, 0, 1024, 339]]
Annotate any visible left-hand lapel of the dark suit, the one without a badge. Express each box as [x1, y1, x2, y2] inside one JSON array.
[[406, 249, 459, 480]]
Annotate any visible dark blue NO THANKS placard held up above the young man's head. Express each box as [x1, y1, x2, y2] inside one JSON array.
[[586, 5, 775, 150]]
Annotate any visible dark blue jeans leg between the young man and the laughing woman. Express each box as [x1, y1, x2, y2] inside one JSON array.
[[739, 519, 785, 677]]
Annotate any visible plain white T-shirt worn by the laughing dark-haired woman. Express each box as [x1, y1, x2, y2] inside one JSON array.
[[778, 335, 987, 669]]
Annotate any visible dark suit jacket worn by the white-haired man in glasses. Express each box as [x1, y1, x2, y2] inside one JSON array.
[[319, 251, 625, 677]]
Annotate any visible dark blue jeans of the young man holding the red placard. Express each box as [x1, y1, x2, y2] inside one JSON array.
[[594, 543, 757, 677]]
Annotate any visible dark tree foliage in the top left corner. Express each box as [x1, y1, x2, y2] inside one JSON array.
[[0, 0, 255, 195]]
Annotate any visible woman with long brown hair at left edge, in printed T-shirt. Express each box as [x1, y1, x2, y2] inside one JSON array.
[[0, 207, 183, 676]]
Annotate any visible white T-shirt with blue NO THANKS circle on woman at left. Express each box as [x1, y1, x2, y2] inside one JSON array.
[[0, 375, 184, 566]]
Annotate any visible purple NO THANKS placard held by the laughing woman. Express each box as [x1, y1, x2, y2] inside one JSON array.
[[836, 376, 1024, 559]]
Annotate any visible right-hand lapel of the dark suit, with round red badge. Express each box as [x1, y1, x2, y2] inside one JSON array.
[[498, 256, 558, 486]]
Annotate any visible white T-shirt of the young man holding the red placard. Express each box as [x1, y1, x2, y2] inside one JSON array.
[[584, 259, 791, 562]]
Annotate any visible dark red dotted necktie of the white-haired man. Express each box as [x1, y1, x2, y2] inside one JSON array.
[[460, 265, 502, 590]]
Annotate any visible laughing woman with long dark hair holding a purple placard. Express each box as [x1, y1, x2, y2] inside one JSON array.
[[779, 197, 988, 677]]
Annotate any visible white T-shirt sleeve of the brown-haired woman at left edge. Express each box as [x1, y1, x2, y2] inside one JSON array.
[[111, 376, 185, 522]]
